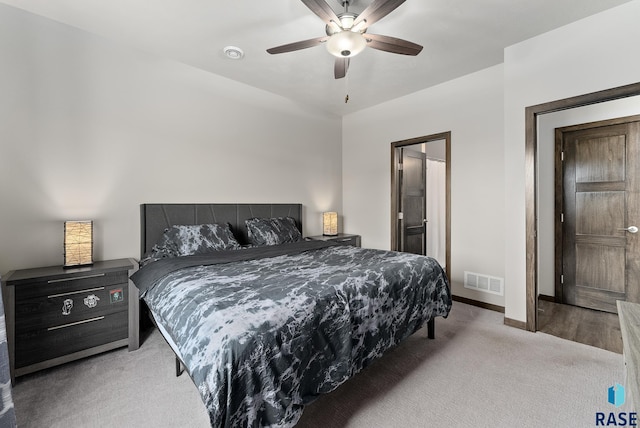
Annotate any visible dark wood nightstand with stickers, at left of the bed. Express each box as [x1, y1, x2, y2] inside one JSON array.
[[2, 259, 139, 382]]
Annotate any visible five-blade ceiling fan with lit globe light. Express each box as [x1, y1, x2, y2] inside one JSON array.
[[267, 0, 422, 79]]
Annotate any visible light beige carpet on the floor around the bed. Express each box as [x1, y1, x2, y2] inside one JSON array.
[[14, 302, 632, 428]]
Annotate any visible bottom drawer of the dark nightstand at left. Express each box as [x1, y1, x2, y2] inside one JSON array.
[[15, 311, 129, 369]]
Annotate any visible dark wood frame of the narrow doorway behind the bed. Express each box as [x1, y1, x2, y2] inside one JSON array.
[[391, 131, 451, 278]]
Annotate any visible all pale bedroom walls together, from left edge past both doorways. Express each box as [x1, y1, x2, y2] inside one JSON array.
[[0, 0, 640, 321]]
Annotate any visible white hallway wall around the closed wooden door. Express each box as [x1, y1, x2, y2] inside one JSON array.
[[538, 97, 640, 296]]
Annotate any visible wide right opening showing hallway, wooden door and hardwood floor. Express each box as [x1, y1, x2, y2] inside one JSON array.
[[537, 114, 640, 353]]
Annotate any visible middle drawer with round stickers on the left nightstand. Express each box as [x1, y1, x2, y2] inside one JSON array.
[[15, 283, 129, 334]]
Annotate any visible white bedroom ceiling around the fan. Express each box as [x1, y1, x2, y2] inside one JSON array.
[[0, 0, 629, 115]]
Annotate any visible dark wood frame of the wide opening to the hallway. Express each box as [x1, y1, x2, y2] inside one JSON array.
[[516, 82, 640, 331]]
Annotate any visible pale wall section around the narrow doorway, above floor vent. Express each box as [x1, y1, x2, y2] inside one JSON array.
[[342, 65, 505, 306]]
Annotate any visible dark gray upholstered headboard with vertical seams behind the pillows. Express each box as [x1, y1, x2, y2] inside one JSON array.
[[140, 204, 302, 257]]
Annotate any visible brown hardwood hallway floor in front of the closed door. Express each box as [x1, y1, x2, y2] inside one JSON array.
[[538, 299, 622, 354]]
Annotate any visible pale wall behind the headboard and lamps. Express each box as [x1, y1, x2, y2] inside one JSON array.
[[0, 5, 343, 273]]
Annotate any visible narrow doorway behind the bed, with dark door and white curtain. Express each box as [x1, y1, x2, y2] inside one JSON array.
[[391, 132, 451, 276]]
